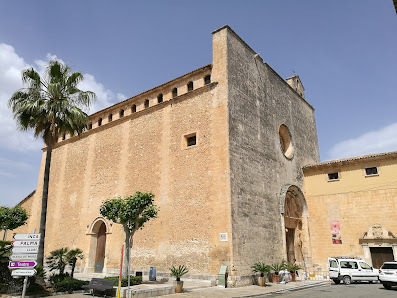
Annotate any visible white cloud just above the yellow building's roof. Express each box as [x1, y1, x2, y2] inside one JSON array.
[[328, 123, 397, 159]]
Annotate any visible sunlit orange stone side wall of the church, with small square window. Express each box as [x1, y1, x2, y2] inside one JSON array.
[[9, 66, 231, 275]]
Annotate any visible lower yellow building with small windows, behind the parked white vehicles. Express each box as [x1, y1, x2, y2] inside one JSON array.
[[303, 152, 397, 270]]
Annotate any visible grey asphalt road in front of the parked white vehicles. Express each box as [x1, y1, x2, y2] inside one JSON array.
[[261, 283, 397, 298]]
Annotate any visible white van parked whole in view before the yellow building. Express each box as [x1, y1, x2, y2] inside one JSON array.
[[328, 257, 379, 285]]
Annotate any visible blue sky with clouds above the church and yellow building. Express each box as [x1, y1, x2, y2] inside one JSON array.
[[0, 0, 397, 206]]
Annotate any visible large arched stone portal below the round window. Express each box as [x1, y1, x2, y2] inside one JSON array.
[[280, 184, 311, 267]]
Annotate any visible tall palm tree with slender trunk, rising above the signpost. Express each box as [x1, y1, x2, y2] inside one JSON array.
[[8, 60, 96, 265]]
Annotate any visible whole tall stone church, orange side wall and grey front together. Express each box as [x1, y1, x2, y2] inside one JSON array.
[[6, 26, 319, 285]]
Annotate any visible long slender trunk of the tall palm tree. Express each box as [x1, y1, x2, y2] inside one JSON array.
[[37, 145, 52, 266]]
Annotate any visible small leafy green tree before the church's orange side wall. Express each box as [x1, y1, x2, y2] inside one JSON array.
[[100, 191, 158, 277]]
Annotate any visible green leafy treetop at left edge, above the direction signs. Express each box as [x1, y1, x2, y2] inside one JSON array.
[[0, 206, 28, 241]]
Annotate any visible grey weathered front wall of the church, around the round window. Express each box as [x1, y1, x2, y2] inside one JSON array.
[[214, 27, 319, 276]]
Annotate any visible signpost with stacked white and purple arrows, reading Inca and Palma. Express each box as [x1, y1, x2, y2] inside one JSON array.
[[8, 230, 41, 298]]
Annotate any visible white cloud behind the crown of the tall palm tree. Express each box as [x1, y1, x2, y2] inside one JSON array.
[[0, 43, 125, 152]]
